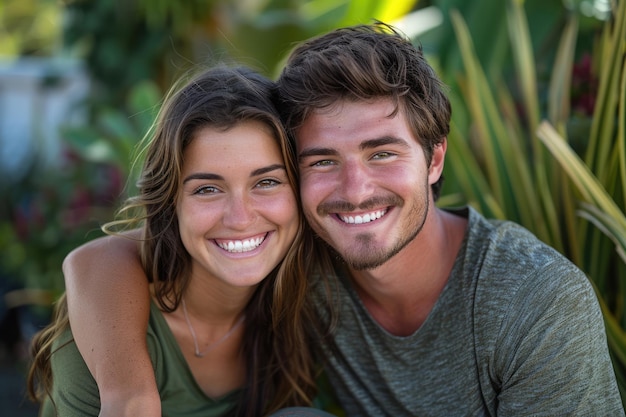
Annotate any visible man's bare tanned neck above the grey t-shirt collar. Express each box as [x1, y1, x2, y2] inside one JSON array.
[[350, 209, 467, 336]]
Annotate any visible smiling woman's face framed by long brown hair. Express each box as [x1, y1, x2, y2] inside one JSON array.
[[176, 121, 299, 287]]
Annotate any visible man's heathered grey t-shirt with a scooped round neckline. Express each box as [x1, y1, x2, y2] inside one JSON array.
[[316, 208, 624, 417]]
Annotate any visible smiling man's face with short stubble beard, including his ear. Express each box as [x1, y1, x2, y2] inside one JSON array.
[[296, 99, 444, 269]]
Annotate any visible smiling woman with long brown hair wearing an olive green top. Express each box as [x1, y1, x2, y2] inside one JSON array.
[[29, 66, 332, 417]]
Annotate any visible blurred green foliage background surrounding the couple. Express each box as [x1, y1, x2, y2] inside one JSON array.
[[0, 0, 626, 406]]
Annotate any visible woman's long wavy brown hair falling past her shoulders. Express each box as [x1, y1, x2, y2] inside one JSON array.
[[28, 66, 334, 416]]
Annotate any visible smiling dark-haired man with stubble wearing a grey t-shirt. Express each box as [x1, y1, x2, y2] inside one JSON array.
[[65, 25, 624, 416]]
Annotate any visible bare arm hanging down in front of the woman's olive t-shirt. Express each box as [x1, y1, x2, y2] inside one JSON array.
[[63, 232, 161, 417]]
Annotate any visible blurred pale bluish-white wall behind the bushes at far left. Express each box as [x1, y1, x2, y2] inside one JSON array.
[[0, 57, 89, 178]]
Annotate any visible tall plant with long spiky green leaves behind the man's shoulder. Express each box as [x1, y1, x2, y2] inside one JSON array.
[[448, 0, 626, 398]]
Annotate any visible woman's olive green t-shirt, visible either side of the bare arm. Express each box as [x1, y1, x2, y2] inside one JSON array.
[[40, 303, 239, 417]]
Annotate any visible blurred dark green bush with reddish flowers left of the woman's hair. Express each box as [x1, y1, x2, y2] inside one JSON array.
[[0, 83, 161, 312]]
